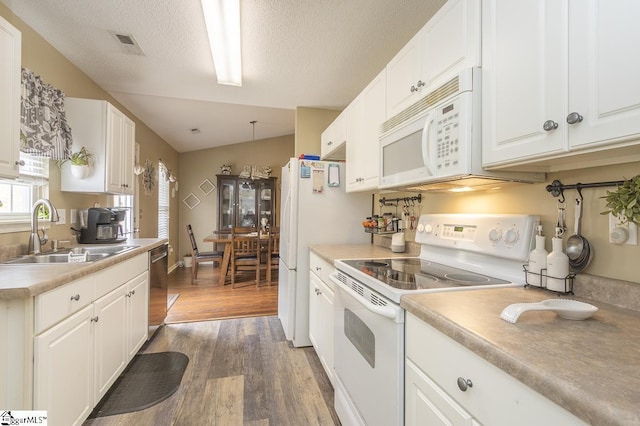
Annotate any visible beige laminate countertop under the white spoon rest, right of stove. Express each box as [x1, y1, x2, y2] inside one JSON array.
[[401, 288, 640, 425]]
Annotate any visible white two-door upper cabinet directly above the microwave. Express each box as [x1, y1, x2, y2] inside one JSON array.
[[386, 0, 481, 118]]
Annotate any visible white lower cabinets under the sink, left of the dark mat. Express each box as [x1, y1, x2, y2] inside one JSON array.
[[33, 254, 149, 425]]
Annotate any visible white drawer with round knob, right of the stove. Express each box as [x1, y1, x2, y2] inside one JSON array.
[[406, 314, 585, 426]]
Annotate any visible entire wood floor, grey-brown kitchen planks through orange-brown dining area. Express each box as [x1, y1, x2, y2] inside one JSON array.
[[84, 265, 340, 426]]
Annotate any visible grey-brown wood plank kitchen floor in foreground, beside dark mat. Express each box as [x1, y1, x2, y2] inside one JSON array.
[[84, 316, 340, 426]]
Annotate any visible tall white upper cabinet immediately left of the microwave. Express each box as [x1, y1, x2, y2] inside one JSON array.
[[346, 70, 386, 192]]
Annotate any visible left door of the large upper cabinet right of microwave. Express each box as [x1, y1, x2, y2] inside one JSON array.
[[482, 0, 568, 165]]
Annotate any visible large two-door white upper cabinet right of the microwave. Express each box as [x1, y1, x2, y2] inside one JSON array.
[[482, 0, 640, 170]]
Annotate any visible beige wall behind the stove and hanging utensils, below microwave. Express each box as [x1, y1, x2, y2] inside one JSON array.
[[378, 162, 640, 283]]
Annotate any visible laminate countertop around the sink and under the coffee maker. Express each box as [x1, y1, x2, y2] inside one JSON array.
[[0, 238, 168, 299]]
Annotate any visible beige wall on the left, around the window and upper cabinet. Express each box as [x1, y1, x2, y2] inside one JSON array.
[[0, 4, 180, 264]]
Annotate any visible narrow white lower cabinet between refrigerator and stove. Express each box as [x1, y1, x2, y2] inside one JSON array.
[[309, 253, 334, 384]]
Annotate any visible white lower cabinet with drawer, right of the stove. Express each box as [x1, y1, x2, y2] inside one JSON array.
[[405, 313, 585, 426]]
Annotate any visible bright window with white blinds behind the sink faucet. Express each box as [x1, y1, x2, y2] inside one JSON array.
[[0, 152, 49, 232]]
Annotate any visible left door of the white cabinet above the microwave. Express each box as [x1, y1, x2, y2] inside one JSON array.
[[386, 30, 425, 118]]
